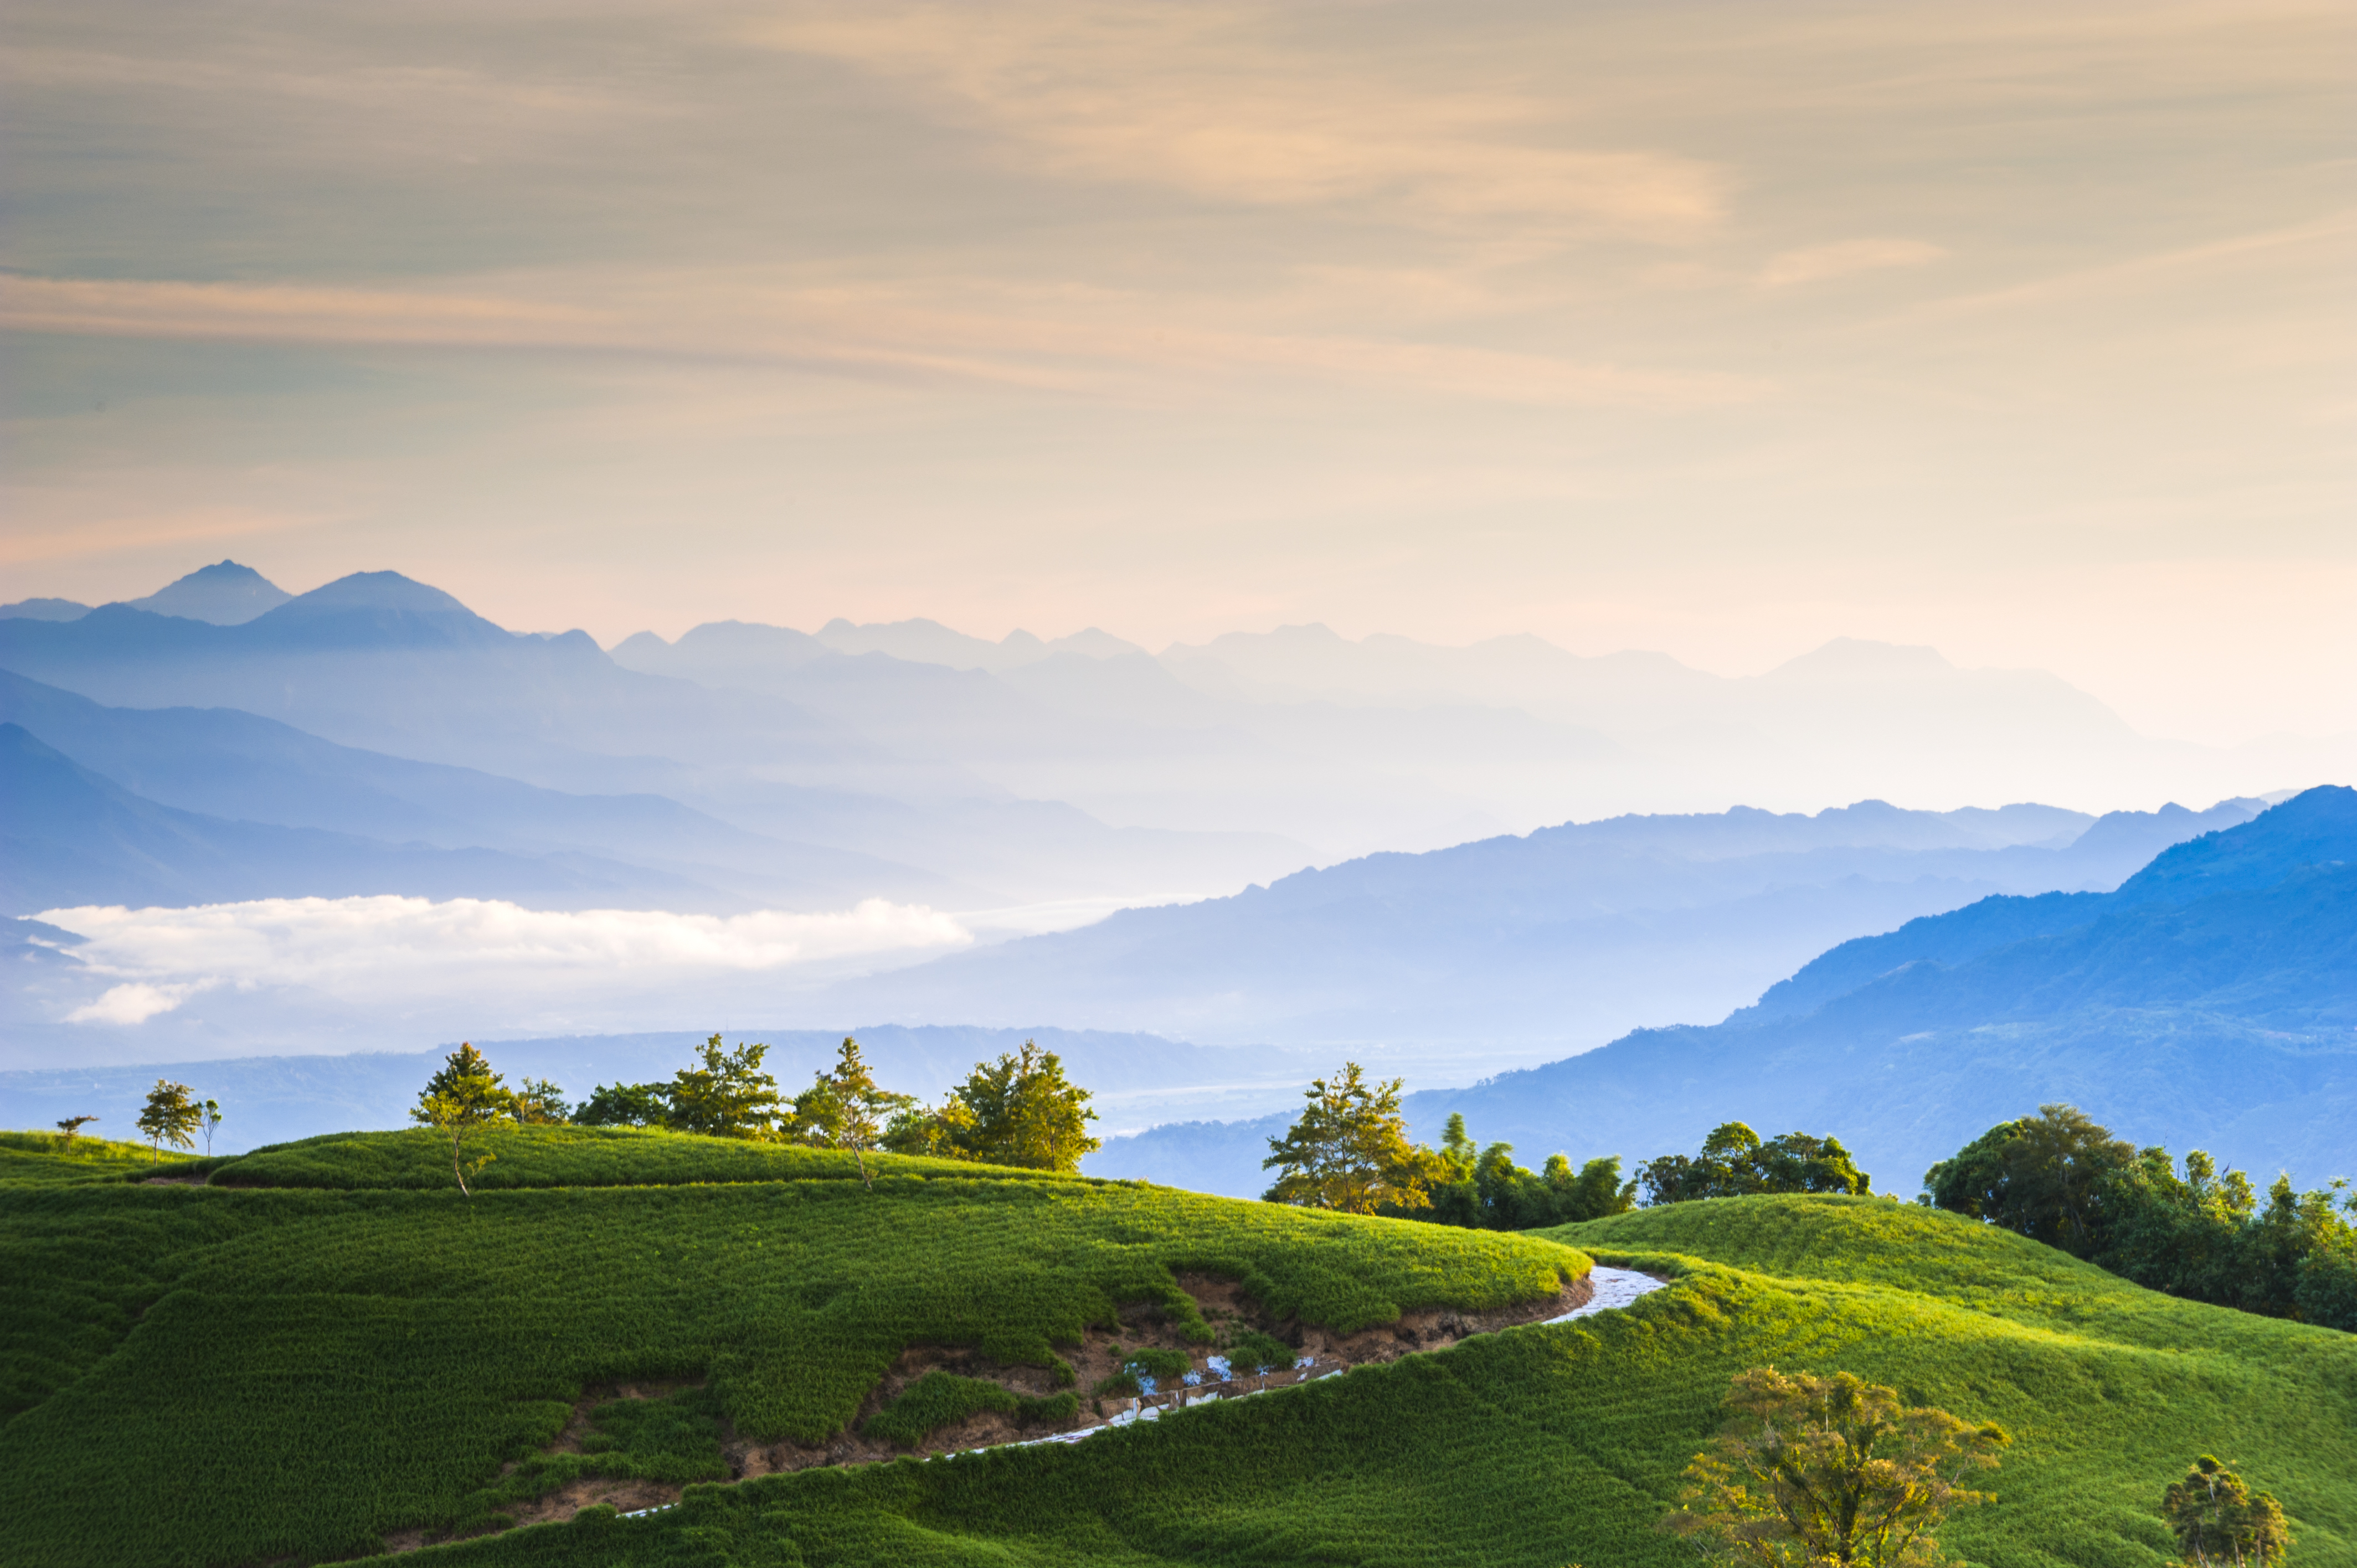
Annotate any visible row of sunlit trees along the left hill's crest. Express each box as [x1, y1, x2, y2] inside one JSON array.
[[410, 1035, 1098, 1191]]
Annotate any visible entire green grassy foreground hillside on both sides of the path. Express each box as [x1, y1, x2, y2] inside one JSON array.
[[0, 1132, 2357, 1568]]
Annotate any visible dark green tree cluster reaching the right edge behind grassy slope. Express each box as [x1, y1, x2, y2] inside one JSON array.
[[1923, 1106, 2357, 1332]]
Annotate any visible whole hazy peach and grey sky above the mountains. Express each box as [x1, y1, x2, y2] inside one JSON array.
[[0, 0, 2357, 740]]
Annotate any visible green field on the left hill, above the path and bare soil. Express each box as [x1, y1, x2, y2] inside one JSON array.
[[0, 1134, 1586, 1568]]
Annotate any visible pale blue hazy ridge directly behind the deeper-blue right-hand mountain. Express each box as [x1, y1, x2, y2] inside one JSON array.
[[820, 800, 2265, 1070]]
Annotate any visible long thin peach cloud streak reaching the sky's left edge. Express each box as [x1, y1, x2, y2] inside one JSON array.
[[0, 271, 1766, 410]]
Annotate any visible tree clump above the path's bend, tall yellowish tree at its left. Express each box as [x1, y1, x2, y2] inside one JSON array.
[[1261, 1061, 1636, 1231]]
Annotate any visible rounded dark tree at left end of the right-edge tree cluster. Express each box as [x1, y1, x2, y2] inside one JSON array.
[[1923, 1106, 2135, 1257]]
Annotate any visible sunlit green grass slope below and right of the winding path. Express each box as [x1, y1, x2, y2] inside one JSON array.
[[337, 1198, 2357, 1568]]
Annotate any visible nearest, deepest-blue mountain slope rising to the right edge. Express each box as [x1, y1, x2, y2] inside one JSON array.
[[1092, 787, 2357, 1193]]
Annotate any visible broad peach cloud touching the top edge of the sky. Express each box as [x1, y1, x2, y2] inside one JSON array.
[[752, 0, 1728, 240]]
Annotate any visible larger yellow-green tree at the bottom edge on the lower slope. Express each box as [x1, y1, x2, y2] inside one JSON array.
[[1661, 1368, 2013, 1568]]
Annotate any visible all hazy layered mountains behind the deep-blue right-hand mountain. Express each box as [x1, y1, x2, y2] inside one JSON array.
[[0, 561, 2314, 1111]]
